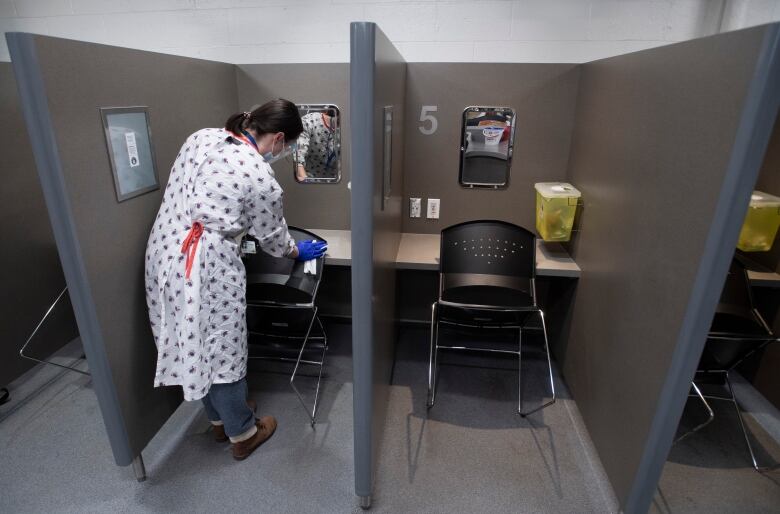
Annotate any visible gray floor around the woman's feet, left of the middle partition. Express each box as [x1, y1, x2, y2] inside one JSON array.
[[0, 325, 356, 513]]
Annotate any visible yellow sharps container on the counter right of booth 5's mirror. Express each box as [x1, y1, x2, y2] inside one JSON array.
[[534, 182, 582, 241]]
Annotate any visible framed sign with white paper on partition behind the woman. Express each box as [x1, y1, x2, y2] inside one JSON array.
[[100, 107, 160, 202]]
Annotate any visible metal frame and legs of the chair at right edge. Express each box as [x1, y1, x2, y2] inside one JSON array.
[[674, 300, 780, 471]]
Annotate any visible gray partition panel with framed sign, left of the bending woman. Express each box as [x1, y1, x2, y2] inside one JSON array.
[[8, 34, 238, 465]]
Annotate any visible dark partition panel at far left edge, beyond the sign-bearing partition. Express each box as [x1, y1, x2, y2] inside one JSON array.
[[0, 62, 78, 387]]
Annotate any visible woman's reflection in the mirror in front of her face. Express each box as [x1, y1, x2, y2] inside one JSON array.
[[295, 112, 338, 182]]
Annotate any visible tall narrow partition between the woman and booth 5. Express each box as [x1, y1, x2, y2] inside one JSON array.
[[350, 22, 406, 506]]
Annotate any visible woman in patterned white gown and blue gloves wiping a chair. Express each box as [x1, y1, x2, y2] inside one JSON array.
[[146, 99, 325, 460]]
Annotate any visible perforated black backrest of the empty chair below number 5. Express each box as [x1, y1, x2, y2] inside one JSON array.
[[439, 220, 536, 279]]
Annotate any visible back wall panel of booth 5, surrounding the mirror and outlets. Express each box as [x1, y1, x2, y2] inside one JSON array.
[[403, 63, 579, 233]]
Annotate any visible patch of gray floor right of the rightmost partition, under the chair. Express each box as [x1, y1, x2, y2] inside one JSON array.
[[650, 376, 780, 514]]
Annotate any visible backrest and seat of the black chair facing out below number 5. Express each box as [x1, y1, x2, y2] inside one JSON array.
[[439, 220, 536, 307]]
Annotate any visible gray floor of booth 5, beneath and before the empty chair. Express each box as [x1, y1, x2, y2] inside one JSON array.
[[375, 324, 617, 513]]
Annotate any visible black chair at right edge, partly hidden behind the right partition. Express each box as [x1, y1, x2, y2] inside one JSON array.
[[675, 256, 778, 470]]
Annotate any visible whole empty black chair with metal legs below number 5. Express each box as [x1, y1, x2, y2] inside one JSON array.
[[428, 221, 555, 417]]
